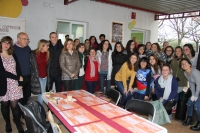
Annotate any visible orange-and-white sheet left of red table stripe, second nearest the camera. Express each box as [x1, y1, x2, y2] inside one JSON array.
[[60, 108, 99, 126]]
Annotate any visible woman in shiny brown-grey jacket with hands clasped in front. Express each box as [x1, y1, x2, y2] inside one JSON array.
[[59, 39, 80, 91]]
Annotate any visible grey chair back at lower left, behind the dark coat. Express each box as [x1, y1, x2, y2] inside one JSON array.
[[18, 103, 47, 133]]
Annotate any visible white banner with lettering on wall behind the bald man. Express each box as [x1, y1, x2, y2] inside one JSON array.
[[0, 17, 26, 42]]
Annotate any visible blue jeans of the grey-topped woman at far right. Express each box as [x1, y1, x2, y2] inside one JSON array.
[[187, 97, 200, 121]]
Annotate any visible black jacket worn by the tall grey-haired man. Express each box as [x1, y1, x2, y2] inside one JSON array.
[[49, 39, 63, 77]]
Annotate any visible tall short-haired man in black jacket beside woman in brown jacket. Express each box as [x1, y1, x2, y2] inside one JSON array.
[[49, 32, 63, 92]]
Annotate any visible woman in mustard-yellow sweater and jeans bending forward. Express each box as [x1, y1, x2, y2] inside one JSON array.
[[115, 54, 138, 107]]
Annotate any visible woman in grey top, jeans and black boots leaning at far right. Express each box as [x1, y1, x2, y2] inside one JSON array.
[[180, 58, 200, 131]]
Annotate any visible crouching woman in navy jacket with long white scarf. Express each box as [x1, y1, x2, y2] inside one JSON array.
[[154, 64, 178, 119]]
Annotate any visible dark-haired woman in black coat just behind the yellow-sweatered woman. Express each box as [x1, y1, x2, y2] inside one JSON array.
[[111, 42, 127, 85]]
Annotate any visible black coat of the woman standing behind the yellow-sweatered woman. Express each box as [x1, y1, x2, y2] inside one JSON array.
[[111, 52, 127, 84]]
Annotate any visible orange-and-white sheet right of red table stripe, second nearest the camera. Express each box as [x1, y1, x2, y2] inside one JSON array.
[[92, 103, 132, 118]]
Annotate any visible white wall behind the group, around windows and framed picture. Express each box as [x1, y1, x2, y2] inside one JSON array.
[[19, 0, 158, 49]]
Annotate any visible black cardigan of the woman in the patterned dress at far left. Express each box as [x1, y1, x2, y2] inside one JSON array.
[[0, 54, 22, 96]]
